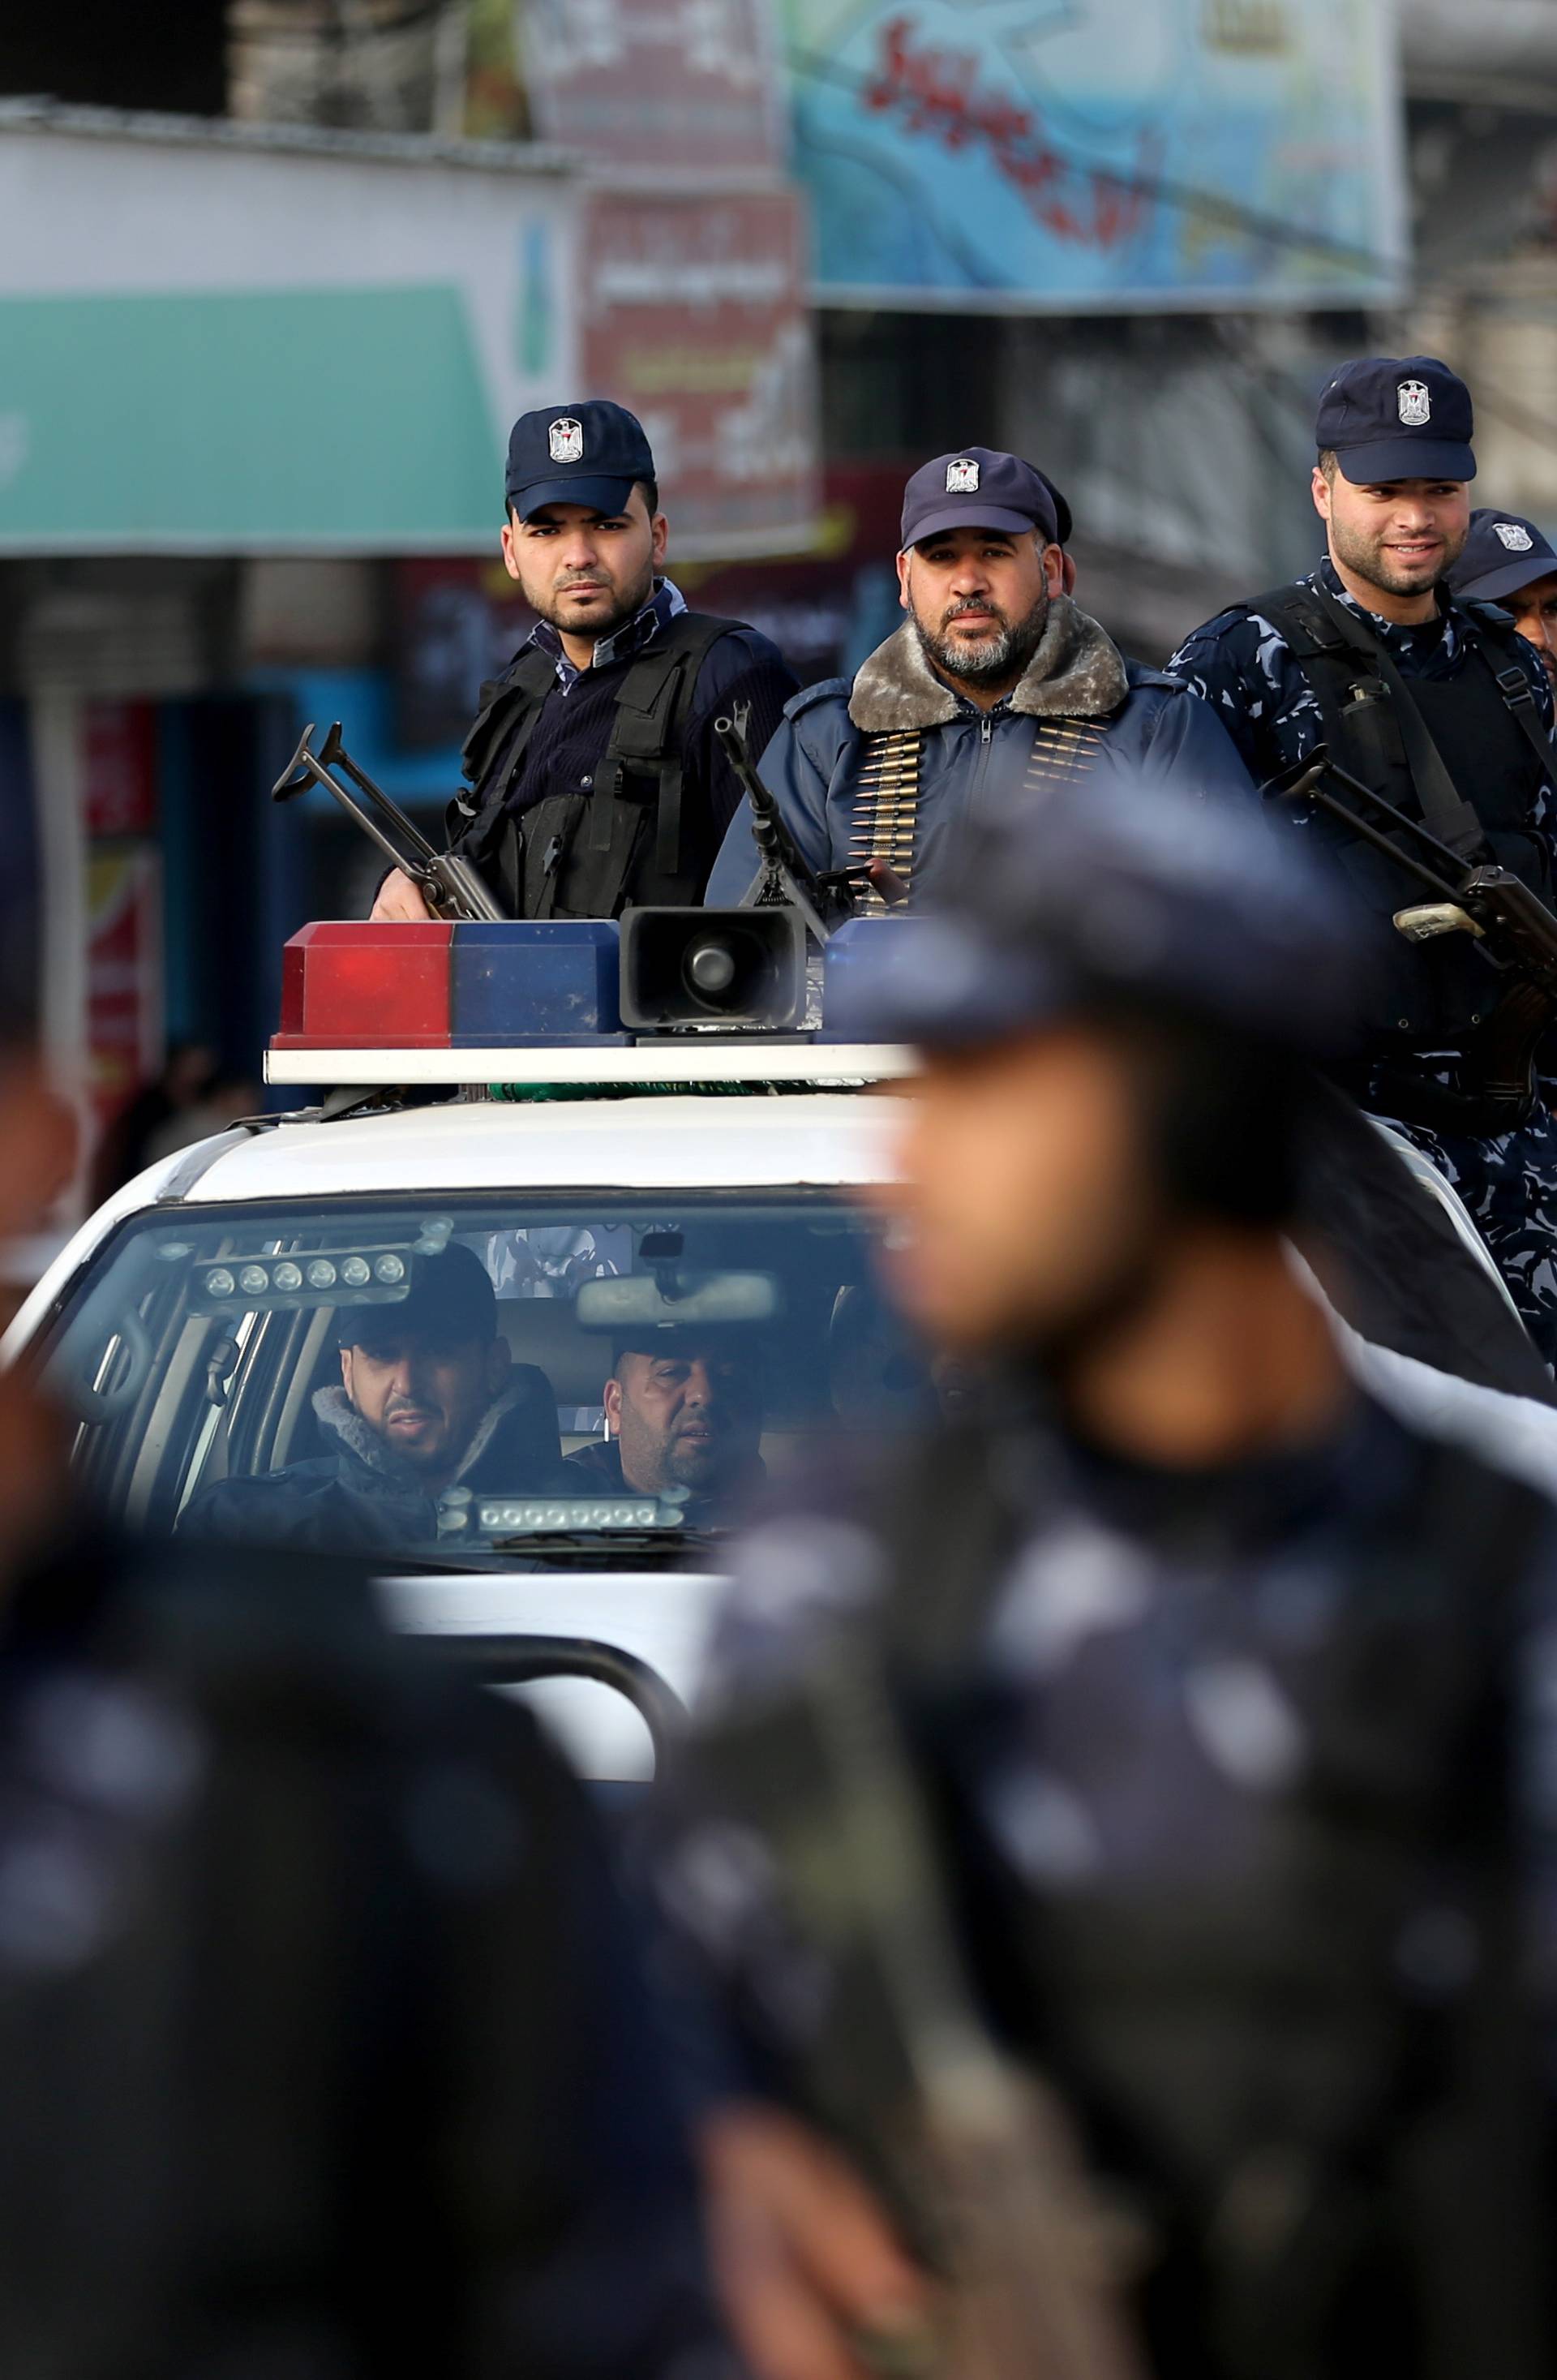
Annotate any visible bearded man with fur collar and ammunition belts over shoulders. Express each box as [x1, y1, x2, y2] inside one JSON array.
[[710, 448, 1247, 907]]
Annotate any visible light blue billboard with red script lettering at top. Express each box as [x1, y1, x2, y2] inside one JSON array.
[[781, 0, 1407, 311]]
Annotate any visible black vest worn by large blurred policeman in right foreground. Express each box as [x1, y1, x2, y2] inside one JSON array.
[[883, 1430, 1552, 2380]]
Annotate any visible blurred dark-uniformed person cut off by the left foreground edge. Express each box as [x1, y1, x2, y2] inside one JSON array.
[[0, 956, 719, 2380]]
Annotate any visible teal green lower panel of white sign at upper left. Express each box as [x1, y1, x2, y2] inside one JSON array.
[[0, 283, 502, 552]]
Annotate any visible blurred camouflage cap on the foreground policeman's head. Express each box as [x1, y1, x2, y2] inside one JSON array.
[[829, 774, 1369, 1059]]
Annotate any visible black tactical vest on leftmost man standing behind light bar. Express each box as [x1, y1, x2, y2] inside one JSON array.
[[448, 612, 736, 917]]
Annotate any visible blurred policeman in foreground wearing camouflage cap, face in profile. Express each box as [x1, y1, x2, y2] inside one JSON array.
[[664, 788, 1557, 2380]]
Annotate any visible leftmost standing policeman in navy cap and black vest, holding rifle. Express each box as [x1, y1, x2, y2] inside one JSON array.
[[374, 400, 796, 919]]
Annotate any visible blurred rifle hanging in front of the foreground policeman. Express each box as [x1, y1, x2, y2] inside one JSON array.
[[688, 1633, 1145, 2380]]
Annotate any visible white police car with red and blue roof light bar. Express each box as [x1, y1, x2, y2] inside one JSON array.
[[0, 912, 1557, 1781]]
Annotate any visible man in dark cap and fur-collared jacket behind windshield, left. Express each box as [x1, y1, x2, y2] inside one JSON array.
[[178, 1243, 567, 1549]]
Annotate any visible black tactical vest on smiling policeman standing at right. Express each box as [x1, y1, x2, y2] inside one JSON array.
[[1250, 586, 1557, 1055]]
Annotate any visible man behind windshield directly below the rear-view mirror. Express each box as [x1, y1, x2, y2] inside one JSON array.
[[567, 1325, 766, 1528]]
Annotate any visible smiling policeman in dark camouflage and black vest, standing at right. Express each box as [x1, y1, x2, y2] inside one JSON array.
[[1171, 354, 1557, 1361]]
